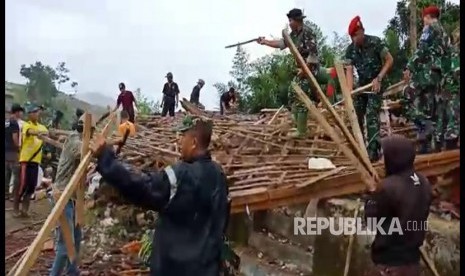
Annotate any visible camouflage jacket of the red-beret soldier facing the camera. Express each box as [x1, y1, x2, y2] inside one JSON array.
[[344, 35, 389, 85]]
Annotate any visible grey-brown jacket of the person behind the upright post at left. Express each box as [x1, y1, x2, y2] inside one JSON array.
[[54, 131, 82, 191]]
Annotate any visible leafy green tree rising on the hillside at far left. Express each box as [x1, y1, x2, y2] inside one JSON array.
[[19, 61, 59, 104]]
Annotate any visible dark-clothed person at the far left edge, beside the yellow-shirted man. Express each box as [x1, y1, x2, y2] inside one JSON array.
[[5, 104, 24, 198]]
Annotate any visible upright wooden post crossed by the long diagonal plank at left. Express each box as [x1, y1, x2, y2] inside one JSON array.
[[75, 112, 92, 226]]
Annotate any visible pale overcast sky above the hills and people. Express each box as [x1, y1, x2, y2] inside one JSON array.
[[5, 0, 459, 108]]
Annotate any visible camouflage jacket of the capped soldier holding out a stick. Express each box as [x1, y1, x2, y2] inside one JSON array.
[[280, 25, 320, 74]]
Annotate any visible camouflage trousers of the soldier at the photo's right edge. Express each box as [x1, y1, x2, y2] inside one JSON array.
[[436, 94, 460, 142]]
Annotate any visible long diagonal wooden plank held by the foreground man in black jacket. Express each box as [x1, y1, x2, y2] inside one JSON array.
[[14, 113, 115, 276]]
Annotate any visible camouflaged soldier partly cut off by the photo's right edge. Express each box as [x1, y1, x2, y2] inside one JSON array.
[[436, 40, 460, 149]]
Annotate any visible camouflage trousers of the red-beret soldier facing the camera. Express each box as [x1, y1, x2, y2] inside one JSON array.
[[354, 93, 382, 160]]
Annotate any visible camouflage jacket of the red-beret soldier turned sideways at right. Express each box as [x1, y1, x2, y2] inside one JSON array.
[[407, 22, 451, 87]]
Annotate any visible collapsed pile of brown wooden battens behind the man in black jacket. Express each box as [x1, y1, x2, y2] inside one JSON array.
[[116, 102, 414, 192]]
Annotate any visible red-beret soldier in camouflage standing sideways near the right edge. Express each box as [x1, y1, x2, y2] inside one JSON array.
[[402, 6, 451, 153]]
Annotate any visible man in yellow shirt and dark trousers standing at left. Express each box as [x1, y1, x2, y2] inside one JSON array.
[[13, 104, 48, 217]]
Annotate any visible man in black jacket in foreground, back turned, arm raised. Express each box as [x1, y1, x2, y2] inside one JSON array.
[[92, 117, 229, 276]]
